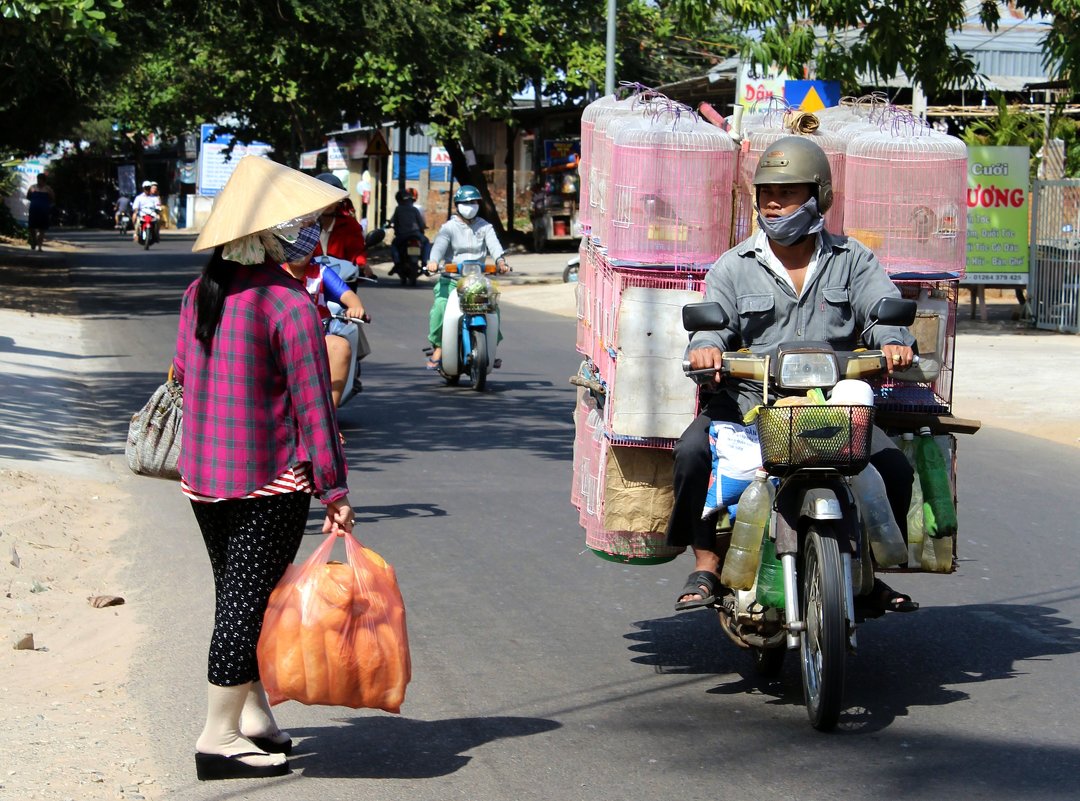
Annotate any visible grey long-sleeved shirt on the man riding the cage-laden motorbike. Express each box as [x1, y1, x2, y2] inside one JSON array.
[[687, 231, 915, 412]]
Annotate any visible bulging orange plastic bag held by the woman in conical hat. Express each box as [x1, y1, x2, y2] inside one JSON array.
[[258, 534, 413, 712]]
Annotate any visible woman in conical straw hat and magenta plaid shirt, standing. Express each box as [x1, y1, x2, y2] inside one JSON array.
[[174, 155, 353, 779]]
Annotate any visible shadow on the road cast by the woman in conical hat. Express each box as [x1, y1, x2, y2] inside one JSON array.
[[289, 717, 561, 778]]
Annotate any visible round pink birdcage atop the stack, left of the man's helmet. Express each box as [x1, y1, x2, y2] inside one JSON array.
[[605, 113, 735, 266]]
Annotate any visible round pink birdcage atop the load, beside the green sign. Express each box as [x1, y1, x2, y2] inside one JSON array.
[[845, 118, 968, 277]]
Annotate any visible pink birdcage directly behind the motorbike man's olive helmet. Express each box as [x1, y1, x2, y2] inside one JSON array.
[[732, 126, 847, 244]]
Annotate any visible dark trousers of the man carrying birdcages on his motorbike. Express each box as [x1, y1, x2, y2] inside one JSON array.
[[667, 393, 915, 551]]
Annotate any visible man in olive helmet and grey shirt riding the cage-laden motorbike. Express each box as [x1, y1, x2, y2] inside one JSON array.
[[667, 136, 918, 614]]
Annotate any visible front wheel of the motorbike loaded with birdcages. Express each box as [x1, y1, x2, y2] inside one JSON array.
[[799, 526, 847, 732]]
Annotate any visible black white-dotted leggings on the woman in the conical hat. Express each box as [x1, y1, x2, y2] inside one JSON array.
[[191, 492, 311, 687]]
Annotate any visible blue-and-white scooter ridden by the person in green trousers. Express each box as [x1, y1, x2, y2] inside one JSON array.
[[438, 261, 499, 392]]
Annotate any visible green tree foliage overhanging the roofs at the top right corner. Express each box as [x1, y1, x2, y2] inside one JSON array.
[[674, 0, 1080, 94]]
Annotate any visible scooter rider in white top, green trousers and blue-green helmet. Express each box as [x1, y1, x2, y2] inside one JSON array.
[[427, 185, 510, 370]]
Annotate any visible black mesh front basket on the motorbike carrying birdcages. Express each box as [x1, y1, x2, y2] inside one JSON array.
[[757, 405, 874, 476]]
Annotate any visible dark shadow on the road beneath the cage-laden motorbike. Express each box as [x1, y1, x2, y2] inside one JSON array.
[[625, 603, 1080, 734]]
